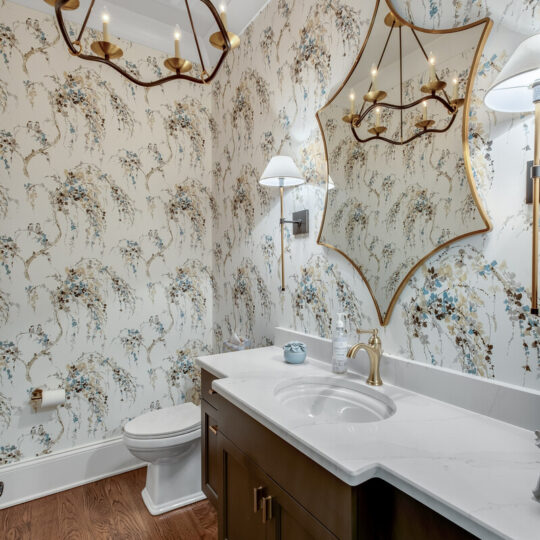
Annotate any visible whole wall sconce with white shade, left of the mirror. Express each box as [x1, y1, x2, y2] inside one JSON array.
[[259, 156, 309, 291]]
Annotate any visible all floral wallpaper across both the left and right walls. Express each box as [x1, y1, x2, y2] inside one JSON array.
[[0, 0, 540, 470]]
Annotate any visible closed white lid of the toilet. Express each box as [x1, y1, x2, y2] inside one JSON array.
[[124, 403, 201, 439]]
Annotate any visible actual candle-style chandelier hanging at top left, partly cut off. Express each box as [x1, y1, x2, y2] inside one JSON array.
[[44, 0, 240, 87]]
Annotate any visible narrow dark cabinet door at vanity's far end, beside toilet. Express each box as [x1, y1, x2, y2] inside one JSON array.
[[201, 400, 220, 508]]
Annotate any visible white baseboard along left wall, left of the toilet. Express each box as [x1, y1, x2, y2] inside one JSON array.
[[0, 437, 146, 509]]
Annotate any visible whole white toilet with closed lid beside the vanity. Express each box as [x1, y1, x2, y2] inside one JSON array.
[[124, 403, 205, 516]]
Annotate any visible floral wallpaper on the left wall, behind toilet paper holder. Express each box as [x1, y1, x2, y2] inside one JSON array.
[[0, 2, 215, 465]]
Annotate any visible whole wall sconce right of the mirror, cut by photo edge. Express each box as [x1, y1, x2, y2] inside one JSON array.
[[484, 34, 540, 315]]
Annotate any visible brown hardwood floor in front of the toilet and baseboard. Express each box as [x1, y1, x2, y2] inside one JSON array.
[[0, 468, 217, 540]]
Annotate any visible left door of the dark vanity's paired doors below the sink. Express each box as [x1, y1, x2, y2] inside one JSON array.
[[218, 433, 267, 540]]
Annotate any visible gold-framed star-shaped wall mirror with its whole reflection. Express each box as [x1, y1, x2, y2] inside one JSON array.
[[317, 0, 492, 325]]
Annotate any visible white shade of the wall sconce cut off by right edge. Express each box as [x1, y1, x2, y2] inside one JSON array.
[[484, 34, 540, 113]]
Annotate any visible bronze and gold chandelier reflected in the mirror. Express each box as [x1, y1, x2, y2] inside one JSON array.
[[342, 12, 465, 145]]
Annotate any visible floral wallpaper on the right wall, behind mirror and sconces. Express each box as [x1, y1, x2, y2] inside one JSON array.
[[212, 0, 540, 389]]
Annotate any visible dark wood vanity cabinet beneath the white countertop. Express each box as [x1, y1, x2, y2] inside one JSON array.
[[201, 370, 474, 540]]
